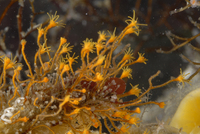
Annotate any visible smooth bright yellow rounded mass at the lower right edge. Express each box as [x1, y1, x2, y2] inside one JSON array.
[[170, 88, 200, 134]]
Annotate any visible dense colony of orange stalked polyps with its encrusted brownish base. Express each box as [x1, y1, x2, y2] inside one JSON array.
[[0, 12, 187, 134]]
